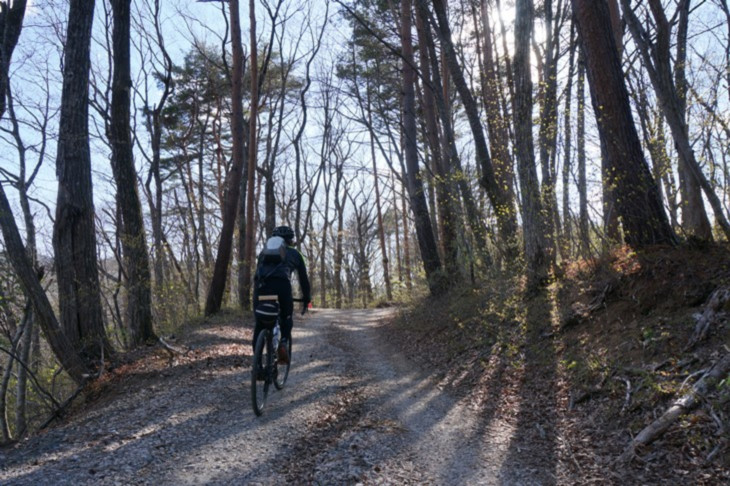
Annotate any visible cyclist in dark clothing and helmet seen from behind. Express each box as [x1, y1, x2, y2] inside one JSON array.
[[252, 226, 312, 363]]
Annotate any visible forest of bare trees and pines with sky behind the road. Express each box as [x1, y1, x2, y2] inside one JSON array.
[[0, 0, 730, 478]]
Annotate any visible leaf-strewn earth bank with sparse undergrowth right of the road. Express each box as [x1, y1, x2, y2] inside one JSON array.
[[386, 245, 730, 483]]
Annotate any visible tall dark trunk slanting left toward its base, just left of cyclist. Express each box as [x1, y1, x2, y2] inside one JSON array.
[[205, 0, 247, 316]]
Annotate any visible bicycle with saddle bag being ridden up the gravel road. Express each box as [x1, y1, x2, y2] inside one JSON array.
[[251, 295, 306, 416]]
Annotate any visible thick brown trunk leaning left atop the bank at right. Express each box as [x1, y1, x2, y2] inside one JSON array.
[[572, 0, 675, 248]]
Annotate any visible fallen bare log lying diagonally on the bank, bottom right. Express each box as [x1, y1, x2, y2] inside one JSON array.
[[619, 353, 730, 462]]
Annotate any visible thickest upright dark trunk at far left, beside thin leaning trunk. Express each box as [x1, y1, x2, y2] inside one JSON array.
[[53, 0, 112, 365]]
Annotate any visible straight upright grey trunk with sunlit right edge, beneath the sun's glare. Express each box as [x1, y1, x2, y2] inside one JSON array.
[[514, 0, 550, 288]]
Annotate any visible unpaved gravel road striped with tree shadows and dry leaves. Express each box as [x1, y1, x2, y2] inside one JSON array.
[[0, 310, 540, 486]]
